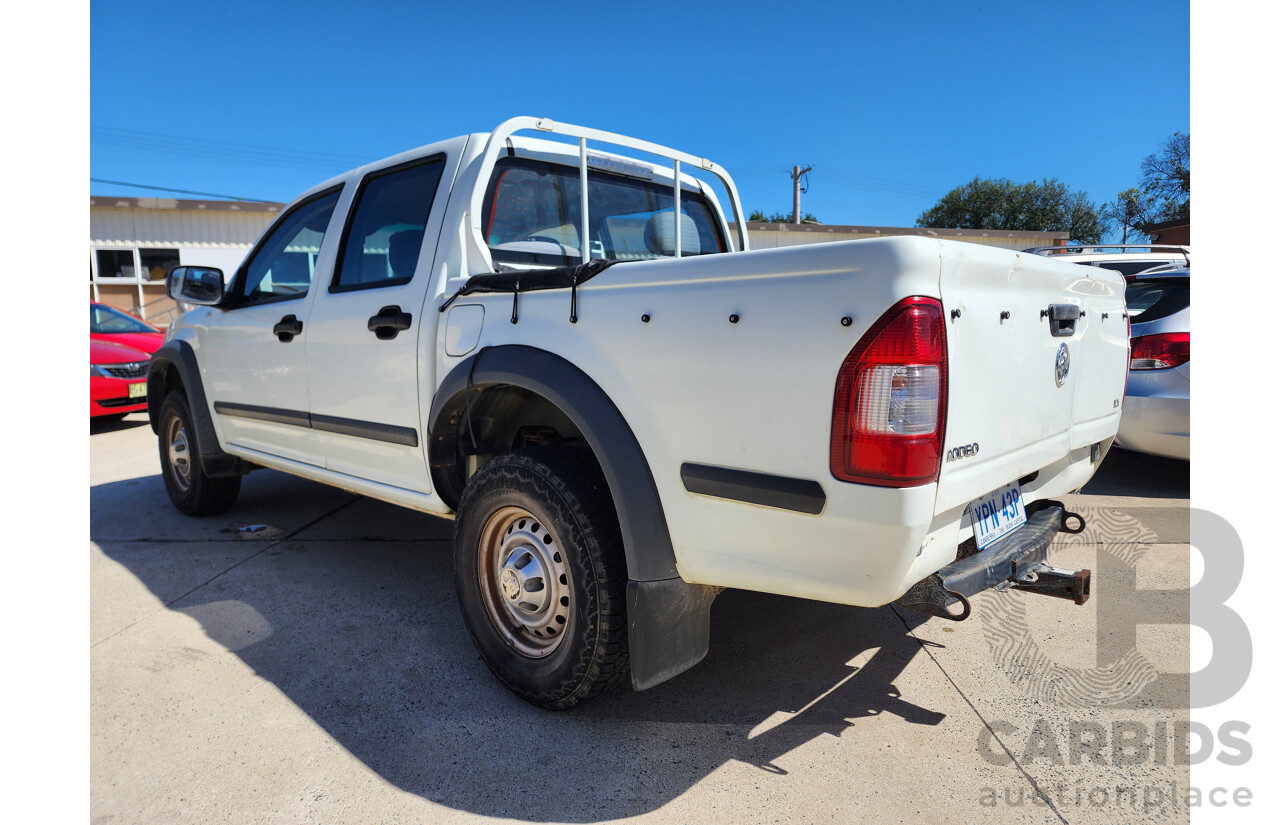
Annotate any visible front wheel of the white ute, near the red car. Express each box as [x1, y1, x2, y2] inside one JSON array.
[[160, 393, 241, 515]]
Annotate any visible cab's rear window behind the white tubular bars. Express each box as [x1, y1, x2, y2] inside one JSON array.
[[484, 157, 726, 266]]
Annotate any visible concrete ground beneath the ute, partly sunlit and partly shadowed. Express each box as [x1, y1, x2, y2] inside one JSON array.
[[90, 414, 1190, 824]]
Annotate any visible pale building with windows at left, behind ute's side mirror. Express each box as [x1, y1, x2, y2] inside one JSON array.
[[88, 197, 284, 326]]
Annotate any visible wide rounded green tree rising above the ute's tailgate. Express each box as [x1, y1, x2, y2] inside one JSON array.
[[915, 178, 1102, 243]]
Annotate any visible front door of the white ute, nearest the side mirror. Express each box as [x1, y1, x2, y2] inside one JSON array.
[[198, 185, 342, 467]]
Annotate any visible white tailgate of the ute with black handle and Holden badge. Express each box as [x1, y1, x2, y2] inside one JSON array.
[[934, 243, 1129, 513]]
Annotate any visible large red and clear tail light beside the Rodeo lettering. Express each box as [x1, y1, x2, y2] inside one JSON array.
[[831, 297, 947, 487]]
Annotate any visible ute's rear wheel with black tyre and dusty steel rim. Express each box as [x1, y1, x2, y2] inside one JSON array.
[[453, 445, 628, 710]]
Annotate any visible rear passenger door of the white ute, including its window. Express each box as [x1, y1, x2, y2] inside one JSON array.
[[306, 138, 465, 492]]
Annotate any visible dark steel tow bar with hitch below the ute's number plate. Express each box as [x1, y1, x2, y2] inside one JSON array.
[[893, 501, 1093, 622]]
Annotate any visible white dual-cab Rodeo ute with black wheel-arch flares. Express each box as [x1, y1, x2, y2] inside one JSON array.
[[147, 118, 1129, 709]]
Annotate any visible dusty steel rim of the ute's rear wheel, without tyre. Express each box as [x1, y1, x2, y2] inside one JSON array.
[[476, 507, 573, 659]]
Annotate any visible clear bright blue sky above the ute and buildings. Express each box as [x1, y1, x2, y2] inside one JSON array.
[[90, 0, 1190, 226]]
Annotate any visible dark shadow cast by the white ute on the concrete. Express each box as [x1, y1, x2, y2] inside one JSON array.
[[90, 473, 945, 822]]
